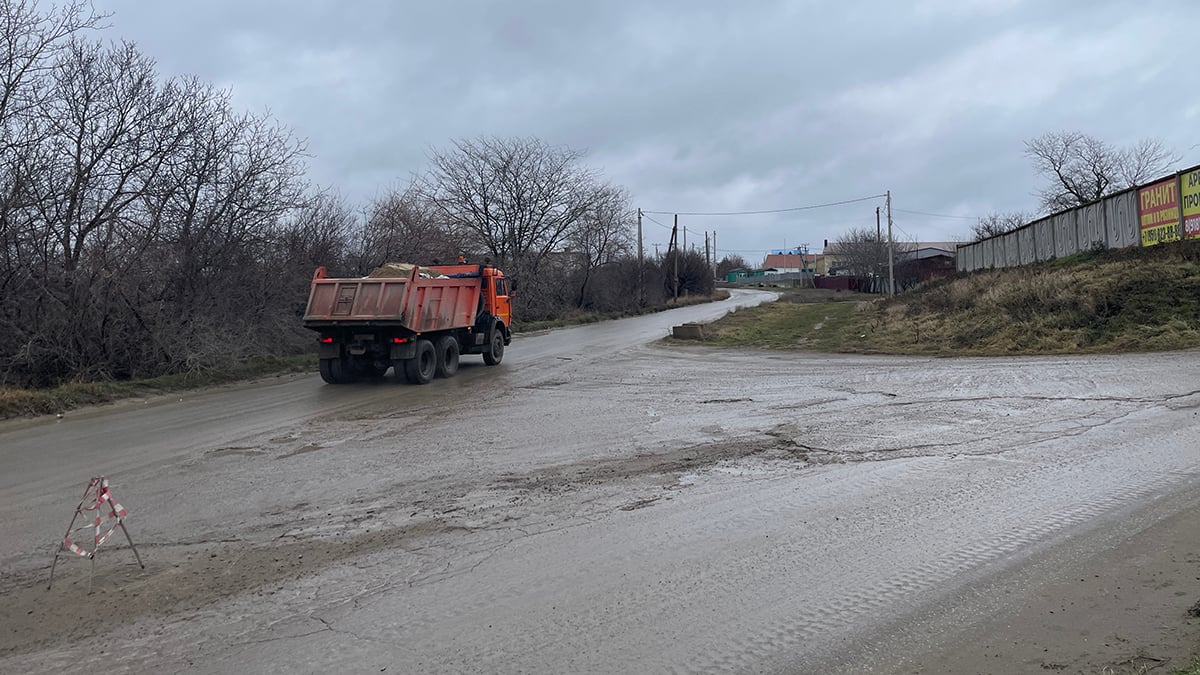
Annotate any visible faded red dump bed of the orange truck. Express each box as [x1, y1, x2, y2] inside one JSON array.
[[304, 265, 482, 333]]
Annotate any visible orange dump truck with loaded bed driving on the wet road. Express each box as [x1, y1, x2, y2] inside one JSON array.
[[304, 263, 512, 384]]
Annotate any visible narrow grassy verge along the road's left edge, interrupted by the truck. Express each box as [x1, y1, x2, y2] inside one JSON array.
[[0, 291, 730, 419]]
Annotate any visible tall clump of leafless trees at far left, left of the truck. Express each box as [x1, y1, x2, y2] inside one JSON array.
[[0, 21, 314, 386]]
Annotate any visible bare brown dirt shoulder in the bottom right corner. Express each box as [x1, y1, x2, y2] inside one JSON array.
[[894, 487, 1200, 675]]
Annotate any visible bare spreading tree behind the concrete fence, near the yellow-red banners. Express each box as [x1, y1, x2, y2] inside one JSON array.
[[1025, 131, 1178, 213]]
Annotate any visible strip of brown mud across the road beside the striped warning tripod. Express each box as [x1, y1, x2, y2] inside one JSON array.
[[0, 425, 806, 657]]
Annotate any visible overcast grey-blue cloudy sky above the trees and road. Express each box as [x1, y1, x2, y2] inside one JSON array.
[[95, 0, 1200, 263]]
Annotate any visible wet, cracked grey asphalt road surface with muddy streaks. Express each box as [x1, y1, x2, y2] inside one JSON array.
[[0, 292, 1200, 673]]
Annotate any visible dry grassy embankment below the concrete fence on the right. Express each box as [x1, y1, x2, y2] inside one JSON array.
[[707, 241, 1200, 356]]
